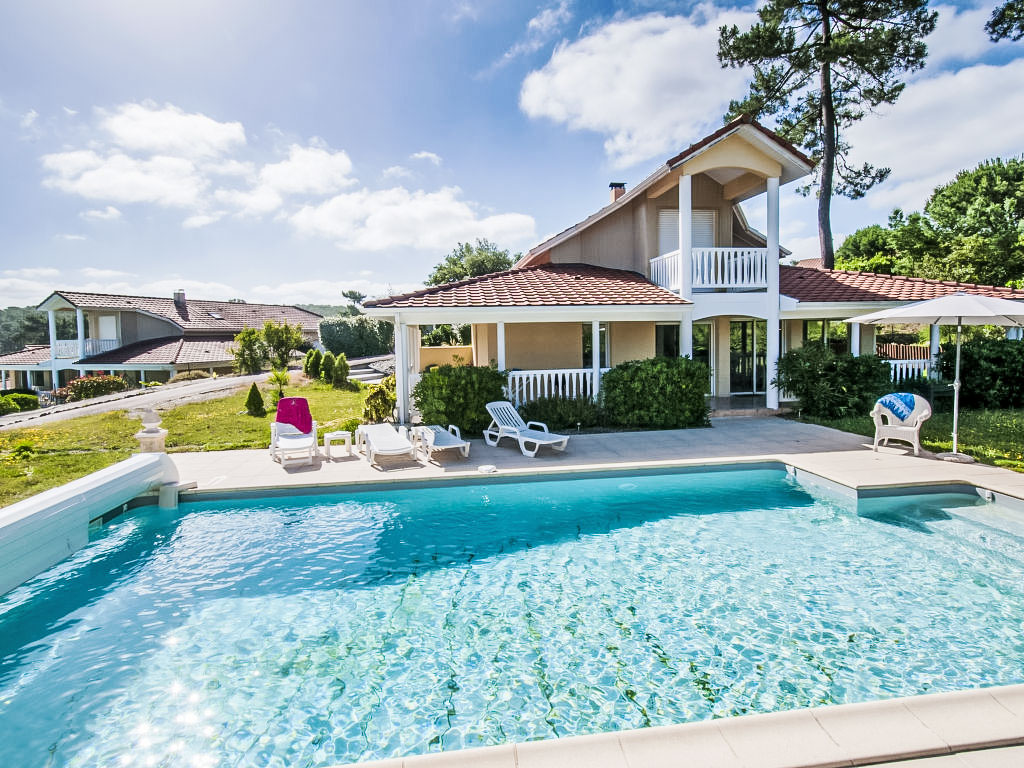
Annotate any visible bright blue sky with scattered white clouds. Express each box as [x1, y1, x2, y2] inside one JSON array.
[[0, 0, 1024, 306]]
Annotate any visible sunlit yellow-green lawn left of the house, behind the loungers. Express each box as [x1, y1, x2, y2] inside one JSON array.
[[0, 384, 367, 507]]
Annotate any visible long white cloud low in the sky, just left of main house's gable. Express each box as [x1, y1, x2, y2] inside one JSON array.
[[291, 186, 535, 251]]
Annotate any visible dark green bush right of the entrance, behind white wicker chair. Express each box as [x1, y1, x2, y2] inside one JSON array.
[[775, 342, 893, 419]]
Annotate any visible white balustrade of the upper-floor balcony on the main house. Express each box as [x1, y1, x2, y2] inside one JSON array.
[[650, 248, 768, 292]]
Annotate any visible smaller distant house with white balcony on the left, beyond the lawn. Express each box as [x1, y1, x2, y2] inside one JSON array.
[[0, 291, 323, 389]]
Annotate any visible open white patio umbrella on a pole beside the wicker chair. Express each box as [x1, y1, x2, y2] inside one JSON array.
[[847, 291, 1024, 462]]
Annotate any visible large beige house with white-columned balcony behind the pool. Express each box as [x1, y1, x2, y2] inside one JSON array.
[[364, 118, 1024, 420]]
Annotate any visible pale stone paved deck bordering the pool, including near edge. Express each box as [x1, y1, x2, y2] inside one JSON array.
[[159, 418, 1024, 768]]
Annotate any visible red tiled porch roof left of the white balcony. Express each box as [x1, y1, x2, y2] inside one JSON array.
[[365, 264, 689, 309]]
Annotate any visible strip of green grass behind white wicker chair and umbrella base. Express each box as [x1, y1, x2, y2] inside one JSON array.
[[804, 409, 1024, 472]]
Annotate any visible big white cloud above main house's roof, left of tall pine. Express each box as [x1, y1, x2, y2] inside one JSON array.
[[519, 4, 755, 167]]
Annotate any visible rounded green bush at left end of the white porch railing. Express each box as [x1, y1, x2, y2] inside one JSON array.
[[413, 366, 506, 435]]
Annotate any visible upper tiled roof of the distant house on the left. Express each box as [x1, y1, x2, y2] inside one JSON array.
[[45, 291, 323, 335]]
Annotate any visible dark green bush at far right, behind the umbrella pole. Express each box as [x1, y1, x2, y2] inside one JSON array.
[[939, 338, 1024, 409]]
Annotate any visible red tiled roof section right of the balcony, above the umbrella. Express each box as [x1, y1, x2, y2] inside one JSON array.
[[778, 266, 1024, 302]]
